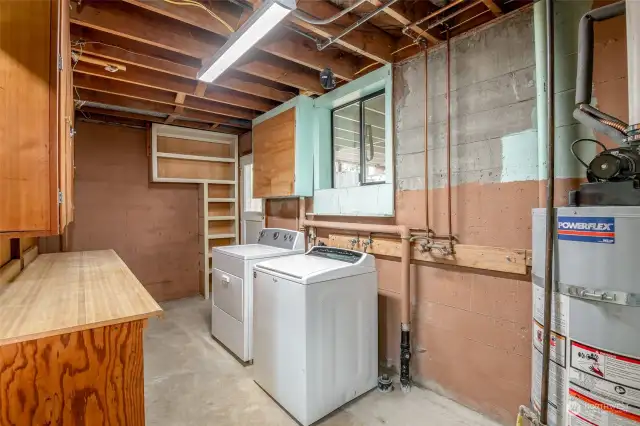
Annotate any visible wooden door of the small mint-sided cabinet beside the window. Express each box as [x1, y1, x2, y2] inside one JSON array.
[[252, 108, 296, 198]]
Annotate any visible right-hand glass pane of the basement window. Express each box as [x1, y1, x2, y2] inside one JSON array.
[[362, 94, 385, 182]]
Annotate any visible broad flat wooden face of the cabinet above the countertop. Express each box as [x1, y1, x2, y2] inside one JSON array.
[[0, 0, 57, 233]]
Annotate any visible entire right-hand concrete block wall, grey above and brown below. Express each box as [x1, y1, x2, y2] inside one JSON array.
[[267, 0, 627, 425]]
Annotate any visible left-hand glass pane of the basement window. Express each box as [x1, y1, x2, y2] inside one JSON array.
[[333, 102, 360, 188]]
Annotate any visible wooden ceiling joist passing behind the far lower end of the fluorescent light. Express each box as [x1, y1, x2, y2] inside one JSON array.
[[71, 25, 296, 102]]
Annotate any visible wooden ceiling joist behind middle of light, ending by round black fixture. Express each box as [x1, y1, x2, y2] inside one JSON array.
[[124, 0, 360, 80]]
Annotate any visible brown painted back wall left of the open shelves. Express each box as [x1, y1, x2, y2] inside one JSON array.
[[69, 122, 199, 301]]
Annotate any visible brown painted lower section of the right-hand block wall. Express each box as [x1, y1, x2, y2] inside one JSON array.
[[267, 179, 581, 425]]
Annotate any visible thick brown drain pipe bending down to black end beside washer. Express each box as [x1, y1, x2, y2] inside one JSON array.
[[300, 215, 411, 392]]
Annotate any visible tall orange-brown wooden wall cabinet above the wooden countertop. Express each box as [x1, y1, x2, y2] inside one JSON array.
[[0, 0, 74, 236]]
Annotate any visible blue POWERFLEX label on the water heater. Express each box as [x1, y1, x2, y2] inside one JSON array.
[[558, 216, 616, 244]]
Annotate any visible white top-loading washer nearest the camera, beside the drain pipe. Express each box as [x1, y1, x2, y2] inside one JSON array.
[[253, 247, 378, 426]]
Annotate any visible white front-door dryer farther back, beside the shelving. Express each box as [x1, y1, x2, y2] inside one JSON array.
[[211, 228, 304, 362]]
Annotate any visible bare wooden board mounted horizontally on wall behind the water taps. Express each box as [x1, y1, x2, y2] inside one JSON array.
[[318, 234, 531, 275]]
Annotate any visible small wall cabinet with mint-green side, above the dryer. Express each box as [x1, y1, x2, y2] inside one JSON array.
[[252, 96, 314, 198]]
